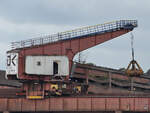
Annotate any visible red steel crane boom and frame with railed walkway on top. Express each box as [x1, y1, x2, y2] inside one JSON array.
[[7, 20, 137, 80]]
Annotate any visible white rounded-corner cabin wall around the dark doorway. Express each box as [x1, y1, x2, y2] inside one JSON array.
[[25, 56, 69, 76]]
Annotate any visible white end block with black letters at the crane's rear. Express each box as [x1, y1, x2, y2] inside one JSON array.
[[6, 53, 18, 75]]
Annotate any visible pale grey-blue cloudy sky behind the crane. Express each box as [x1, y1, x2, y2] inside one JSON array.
[[0, 0, 150, 72]]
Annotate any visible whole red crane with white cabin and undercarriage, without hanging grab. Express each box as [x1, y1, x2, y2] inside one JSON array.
[[6, 20, 137, 99]]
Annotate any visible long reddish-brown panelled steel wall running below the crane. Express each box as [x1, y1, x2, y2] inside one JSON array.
[[0, 97, 150, 112]]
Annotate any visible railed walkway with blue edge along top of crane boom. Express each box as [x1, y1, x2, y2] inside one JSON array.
[[11, 20, 137, 49]]
